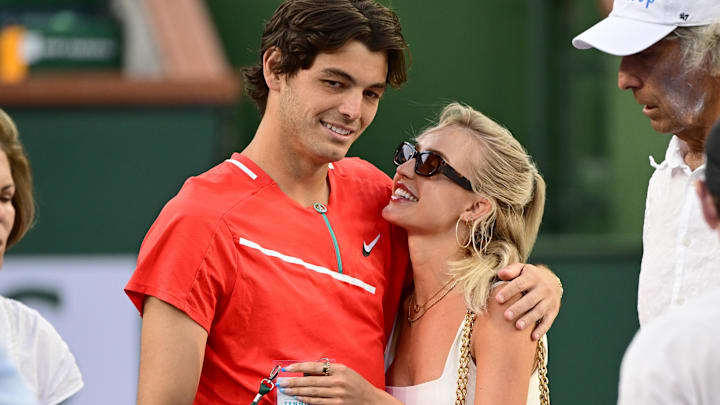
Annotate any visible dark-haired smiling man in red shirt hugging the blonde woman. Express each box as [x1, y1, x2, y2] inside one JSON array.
[[126, 0, 560, 404]]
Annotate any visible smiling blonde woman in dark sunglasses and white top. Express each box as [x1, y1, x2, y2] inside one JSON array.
[[278, 103, 545, 405]]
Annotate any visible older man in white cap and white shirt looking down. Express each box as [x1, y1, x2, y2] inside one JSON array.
[[573, 0, 720, 327]]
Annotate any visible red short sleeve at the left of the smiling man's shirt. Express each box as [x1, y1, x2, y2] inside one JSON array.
[[125, 191, 237, 333]]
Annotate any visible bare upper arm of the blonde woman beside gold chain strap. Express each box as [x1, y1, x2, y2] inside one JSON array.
[[472, 287, 537, 405]]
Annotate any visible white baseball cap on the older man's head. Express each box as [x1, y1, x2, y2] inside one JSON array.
[[573, 0, 720, 56]]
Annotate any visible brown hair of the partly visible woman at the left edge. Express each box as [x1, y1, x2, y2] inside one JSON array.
[[0, 109, 35, 247]]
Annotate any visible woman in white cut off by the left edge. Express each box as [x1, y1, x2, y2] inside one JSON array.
[[0, 110, 83, 405]]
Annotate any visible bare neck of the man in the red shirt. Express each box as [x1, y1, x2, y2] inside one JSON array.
[[242, 120, 330, 207]]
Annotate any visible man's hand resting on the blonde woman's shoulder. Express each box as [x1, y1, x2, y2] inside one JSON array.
[[495, 263, 563, 340]]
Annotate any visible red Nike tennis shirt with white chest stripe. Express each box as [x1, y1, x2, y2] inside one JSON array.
[[125, 153, 408, 404]]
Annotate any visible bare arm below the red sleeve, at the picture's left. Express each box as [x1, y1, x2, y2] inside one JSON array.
[[138, 297, 207, 405]]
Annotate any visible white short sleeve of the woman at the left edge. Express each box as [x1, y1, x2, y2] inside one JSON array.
[[9, 300, 83, 405]]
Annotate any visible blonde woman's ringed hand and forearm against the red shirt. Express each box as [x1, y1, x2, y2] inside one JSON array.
[[276, 362, 400, 405]]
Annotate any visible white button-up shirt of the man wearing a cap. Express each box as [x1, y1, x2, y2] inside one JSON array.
[[638, 136, 720, 326]]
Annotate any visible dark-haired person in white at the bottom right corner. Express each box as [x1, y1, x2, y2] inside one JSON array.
[[618, 122, 720, 405]]
